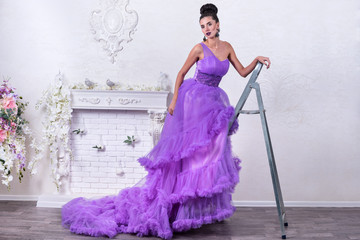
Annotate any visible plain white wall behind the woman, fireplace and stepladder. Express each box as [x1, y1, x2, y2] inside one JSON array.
[[0, 0, 360, 201]]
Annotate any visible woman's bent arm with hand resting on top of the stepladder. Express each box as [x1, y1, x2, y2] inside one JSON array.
[[227, 43, 271, 77]]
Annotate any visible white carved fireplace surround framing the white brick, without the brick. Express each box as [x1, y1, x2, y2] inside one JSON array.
[[37, 90, 170, 207]]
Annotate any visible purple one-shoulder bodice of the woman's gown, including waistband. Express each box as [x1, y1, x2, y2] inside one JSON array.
[[194, 43, 229, 87]]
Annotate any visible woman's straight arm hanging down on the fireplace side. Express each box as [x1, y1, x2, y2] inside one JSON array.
[[168, 43, 203, 115]]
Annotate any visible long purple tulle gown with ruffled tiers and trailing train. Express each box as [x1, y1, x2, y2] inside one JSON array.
[[62, 43, 240, 239]]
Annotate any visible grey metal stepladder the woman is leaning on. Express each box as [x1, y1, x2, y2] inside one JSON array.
[[229, 62, 288, 239]]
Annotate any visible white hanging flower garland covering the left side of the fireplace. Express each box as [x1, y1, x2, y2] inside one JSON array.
[[36, 73, 72, 191]]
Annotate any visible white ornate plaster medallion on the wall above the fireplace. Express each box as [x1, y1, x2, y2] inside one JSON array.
[[90, 0, 138, 63]]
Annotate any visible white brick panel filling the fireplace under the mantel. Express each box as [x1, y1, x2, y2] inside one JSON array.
[[70, 110, 152, 195]]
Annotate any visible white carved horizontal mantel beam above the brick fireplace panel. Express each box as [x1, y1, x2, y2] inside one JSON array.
[[71, 90, 170, 112]]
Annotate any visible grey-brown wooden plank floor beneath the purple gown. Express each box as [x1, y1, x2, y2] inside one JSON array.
[[0, 201, 360, 240]]
